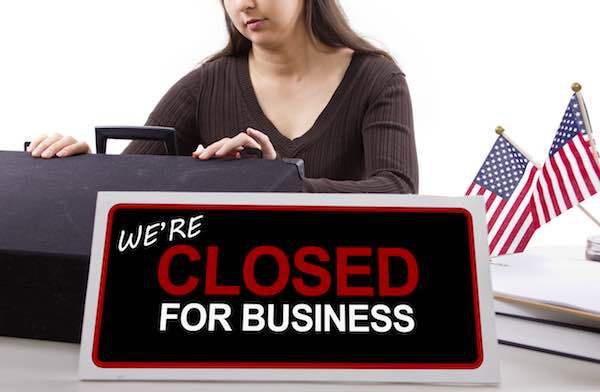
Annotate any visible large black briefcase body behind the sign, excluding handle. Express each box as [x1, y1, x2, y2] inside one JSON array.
[[0, 151, 302, 342]]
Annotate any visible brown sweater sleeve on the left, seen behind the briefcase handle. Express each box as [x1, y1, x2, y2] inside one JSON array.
[[122, 73, 200, 155]]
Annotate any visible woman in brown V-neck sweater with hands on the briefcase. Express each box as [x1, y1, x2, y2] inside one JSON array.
[[28, 0, 418, 193]]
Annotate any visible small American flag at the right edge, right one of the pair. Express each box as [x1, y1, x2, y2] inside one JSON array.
[[533, 94, 600, 224]]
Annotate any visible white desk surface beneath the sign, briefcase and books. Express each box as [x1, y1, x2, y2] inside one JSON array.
[[0, 337, 600, 392]]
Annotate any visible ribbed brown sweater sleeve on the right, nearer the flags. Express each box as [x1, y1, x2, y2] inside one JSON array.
[[304, 73, 419, 193]]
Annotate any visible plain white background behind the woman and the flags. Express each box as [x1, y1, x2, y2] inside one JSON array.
[[0, 0, 600, 245]]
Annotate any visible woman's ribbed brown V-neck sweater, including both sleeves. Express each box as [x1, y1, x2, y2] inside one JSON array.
[[123, 53, 418, 193]]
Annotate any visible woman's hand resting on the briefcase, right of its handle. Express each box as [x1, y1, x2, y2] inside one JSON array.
[[192, 128, 277, 160]]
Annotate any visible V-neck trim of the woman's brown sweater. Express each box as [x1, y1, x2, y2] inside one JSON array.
[[237, 52, 358, 154]]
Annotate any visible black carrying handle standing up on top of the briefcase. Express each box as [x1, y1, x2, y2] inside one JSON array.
[[96, 126, 177, 155]]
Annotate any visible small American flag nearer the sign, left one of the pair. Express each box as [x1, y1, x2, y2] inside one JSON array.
[[466, 136, 539, 256]]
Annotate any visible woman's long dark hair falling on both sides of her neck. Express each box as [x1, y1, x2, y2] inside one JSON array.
[[206, 0, 394, 62]]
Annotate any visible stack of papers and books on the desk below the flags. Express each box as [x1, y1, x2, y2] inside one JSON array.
[[491, 248, 600, 362]]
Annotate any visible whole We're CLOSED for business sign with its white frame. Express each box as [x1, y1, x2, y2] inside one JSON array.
[[79, 192, 499, 383]]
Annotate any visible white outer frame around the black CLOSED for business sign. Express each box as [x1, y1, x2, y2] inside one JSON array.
[[79, 192, 500, 384]]
